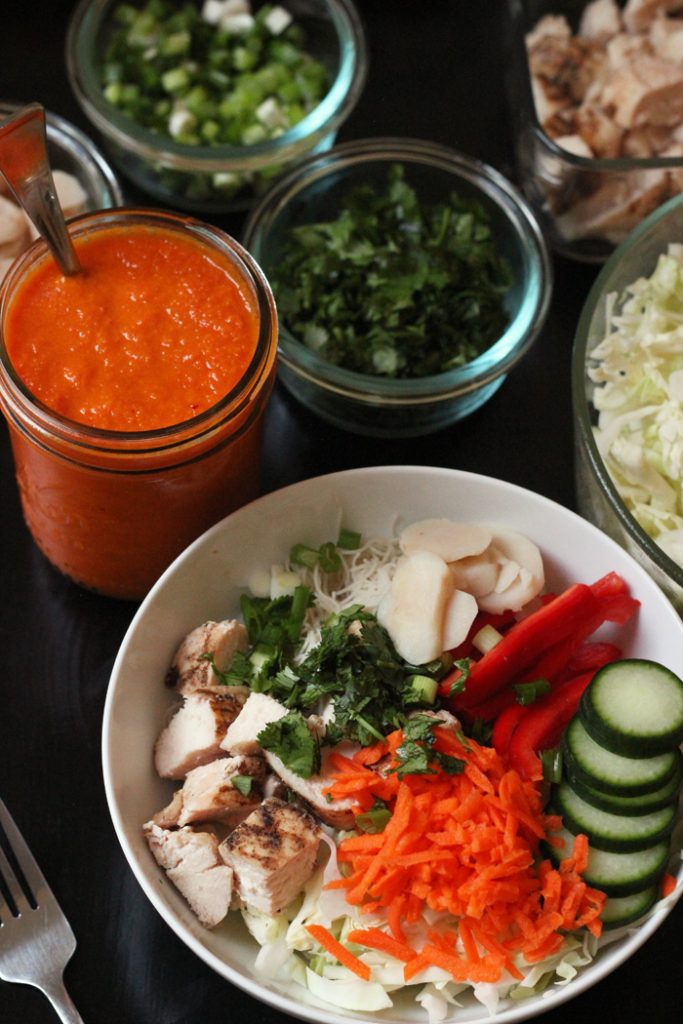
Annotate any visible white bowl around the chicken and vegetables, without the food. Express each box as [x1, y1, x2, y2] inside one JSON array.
[[102, 466, 683, 1024]]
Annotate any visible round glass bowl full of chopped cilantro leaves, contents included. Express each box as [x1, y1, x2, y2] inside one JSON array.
[[244, 138, 552, 437]]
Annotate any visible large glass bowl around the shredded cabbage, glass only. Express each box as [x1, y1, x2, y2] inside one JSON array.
[[571, 196, 683, 612]]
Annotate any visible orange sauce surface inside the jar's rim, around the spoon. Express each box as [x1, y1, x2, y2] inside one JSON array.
[[5, 227, 258, 431]]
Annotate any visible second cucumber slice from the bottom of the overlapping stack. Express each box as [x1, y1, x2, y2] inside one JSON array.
[[549, 828, 669, 896]]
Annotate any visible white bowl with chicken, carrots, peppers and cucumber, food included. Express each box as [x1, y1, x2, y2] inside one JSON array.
[[102, 466, 683, 1024]]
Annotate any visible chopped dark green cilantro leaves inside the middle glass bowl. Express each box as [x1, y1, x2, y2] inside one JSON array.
[[272, 164, 512, 378]]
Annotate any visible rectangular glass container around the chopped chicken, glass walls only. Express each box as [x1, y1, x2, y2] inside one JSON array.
[[508, 0, 683, 263]]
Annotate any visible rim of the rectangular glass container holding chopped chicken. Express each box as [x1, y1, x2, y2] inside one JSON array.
[[507, 0, 683, 174]]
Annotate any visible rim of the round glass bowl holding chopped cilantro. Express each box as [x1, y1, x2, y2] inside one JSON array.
[[242, 136, 553, 406]]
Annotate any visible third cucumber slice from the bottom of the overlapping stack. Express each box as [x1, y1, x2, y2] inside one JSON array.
[[553, 780, 676, 853]]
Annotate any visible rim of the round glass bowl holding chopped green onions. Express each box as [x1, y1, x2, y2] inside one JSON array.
[[66, 0, 369, 172]]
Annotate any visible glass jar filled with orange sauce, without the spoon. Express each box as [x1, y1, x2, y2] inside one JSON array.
[[0, 218, 276, 600]]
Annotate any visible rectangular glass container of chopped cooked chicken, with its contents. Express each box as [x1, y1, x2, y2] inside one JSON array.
[[508, 0, 683, 262]]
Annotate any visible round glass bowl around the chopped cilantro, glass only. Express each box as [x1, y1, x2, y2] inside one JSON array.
[[244, 138, 552, 437]]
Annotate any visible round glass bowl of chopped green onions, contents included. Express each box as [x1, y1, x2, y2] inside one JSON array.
[[67, 0, 367, 213]]
